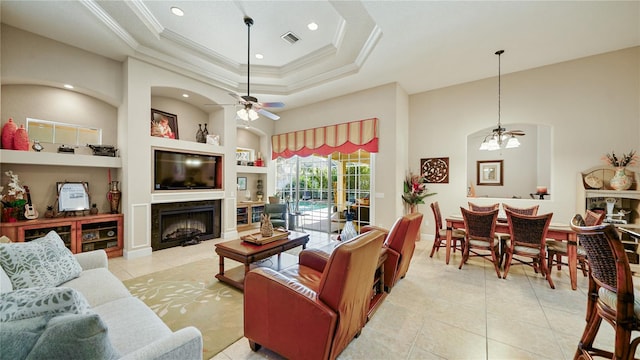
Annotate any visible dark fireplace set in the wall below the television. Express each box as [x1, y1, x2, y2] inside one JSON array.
[[151, 200, 222, 251]]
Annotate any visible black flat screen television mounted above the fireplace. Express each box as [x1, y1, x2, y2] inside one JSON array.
[[153, 149, 222, 190]]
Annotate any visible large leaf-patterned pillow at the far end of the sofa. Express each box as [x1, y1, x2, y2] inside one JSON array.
[[0, 231, 82, 289]]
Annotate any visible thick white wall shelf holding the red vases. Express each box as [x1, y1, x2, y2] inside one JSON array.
[[0, 150, 122, 168]]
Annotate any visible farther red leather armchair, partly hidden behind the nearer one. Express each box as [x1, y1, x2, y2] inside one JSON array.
[[360, 213, 423, 292]]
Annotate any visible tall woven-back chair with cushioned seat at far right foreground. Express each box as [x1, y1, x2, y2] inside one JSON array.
[[571, 214, 640, 359]]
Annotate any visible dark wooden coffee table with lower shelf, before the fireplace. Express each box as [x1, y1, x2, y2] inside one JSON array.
[[216, 231, 309, 290]]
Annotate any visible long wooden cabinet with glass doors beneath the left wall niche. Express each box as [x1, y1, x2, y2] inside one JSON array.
[[0, 214, 124, 257]]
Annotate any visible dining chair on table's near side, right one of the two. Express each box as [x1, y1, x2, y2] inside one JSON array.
[[502, 210, 556, 289]]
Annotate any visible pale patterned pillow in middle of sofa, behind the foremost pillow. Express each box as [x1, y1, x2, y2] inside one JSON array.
[[0, 287, 90, 322]]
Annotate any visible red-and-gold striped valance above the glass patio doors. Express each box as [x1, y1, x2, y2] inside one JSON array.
[[271, 118, 378, 159]]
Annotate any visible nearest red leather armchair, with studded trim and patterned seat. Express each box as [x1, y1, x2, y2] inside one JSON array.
[[244, 231, 385, 359]]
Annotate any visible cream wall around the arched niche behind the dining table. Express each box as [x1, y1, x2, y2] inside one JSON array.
[[412, 47, 640, 234]]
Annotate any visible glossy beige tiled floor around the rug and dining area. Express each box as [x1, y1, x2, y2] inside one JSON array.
[[109, 234, 613, 360]]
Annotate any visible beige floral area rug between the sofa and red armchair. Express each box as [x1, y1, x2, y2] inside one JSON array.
[[124, 259, 243, 359]]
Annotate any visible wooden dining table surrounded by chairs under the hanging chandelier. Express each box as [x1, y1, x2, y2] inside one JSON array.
[[445, 215, 578, 290]]
